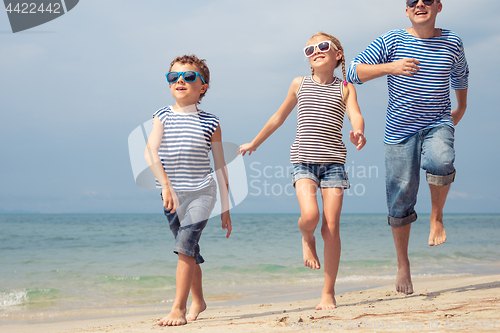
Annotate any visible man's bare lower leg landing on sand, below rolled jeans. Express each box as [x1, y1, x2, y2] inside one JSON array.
[[392, 224, 413, 295]]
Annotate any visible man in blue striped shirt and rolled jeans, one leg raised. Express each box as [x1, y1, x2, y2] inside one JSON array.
[[348, 0, 469, 294]]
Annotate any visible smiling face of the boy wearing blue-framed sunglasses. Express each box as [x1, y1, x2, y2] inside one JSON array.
[[169, 62, 208, 107]]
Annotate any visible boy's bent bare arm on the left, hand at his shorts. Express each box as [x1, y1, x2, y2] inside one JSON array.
[[144, 116, 179, 213]]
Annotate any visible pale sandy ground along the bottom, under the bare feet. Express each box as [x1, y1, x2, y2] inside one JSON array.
[[0, 275, 500, 333]]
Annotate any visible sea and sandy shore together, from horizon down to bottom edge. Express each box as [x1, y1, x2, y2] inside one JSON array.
[[0, 214, 500, 333]]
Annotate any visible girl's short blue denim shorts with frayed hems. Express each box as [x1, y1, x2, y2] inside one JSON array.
[[293, 163, 349, 189]]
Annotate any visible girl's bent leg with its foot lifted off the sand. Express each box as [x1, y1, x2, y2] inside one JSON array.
[[295, 178, 321, 269]]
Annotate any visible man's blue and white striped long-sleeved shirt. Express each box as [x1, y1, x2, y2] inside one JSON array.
[[347, 29, 469, 144]]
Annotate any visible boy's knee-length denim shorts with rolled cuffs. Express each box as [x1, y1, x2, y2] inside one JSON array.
[[163, 181, 217, 264]]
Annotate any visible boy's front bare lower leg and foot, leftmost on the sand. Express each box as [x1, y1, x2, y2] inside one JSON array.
[[157, 253, 196, 326]]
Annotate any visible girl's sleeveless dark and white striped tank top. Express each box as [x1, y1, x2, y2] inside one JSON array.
[[290, 76, 347, 164]]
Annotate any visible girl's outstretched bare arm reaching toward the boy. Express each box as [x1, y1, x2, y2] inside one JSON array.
[[238, 77, 302, 156]]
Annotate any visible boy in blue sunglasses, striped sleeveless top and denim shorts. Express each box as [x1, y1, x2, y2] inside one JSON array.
[[145, 55, 231, 326]]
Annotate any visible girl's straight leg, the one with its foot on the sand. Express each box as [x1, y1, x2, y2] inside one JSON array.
[[316, 188, 344, 310]]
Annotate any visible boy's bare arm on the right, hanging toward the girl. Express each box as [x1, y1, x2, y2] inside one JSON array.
[[210, 126, 232, 238]]
